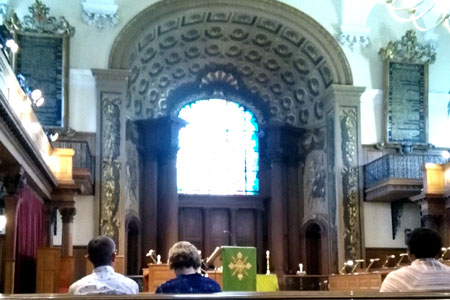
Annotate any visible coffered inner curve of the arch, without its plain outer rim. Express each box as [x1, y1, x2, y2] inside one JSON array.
[[127, 8, 334, 127]]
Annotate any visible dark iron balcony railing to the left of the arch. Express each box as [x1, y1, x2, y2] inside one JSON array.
[[53, 140, 95, 178]]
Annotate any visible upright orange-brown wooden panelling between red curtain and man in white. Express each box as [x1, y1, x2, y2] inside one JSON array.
[[36, 247, 61, 293]]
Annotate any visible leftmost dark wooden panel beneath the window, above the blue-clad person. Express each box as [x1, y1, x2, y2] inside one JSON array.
[[179, 208, 203, 251]]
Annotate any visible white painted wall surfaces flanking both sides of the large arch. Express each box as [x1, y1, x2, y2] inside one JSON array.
[[10, 0, 450, 247]]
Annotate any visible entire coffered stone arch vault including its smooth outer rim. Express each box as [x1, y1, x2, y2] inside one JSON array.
[[110, 0, 352, 127]]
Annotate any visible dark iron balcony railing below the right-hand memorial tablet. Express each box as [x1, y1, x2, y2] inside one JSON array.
[[364, 154, 447, 188]]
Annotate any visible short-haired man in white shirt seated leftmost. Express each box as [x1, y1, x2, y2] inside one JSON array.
[[69, 236, 139, 295]]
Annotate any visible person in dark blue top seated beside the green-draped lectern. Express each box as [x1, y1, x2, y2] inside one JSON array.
[[156, 242, 222, 294]]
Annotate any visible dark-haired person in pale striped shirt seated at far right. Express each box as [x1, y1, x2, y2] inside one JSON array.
[[380, 228, 450, 292]]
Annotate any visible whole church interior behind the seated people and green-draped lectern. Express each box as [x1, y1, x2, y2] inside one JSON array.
[[0, 0, 450, 294]]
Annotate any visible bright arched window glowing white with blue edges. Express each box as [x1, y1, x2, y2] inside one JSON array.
[[177, 99, 259, 195]]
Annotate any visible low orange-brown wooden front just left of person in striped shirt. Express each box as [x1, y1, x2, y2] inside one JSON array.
[[328, 273, 382, 291]]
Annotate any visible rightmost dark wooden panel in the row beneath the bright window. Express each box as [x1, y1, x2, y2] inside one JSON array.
[[236, 209, 256, 247]]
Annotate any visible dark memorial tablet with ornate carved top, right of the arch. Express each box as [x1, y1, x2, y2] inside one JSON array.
[[380, 30, 435, 146]]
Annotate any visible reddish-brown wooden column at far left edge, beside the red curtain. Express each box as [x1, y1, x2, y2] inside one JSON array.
[[3, 167, 25, 294]]
